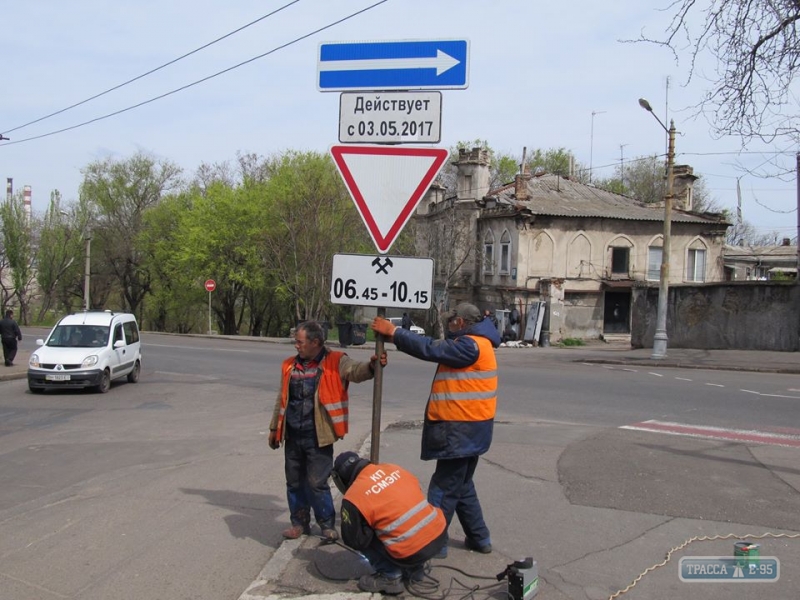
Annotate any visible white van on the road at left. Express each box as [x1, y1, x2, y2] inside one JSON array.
[[28, 310, 142, 393]]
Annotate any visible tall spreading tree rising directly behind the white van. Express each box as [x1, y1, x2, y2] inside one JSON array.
[[80, 153, 181, 313]]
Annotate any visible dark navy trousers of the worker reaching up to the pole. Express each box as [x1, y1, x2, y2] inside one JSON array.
[[428, 456, 491, 546]]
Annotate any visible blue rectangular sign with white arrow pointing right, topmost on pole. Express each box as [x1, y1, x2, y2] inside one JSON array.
[[317, 40, 469, 92]]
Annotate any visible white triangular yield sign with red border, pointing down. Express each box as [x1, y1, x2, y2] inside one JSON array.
[[331, 146, 450, 254]]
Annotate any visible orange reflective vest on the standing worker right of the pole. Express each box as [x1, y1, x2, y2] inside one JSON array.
[[427, 335, 497, 421]]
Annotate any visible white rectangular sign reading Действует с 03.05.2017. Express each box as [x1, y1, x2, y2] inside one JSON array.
[[339, 92, 442, 144]]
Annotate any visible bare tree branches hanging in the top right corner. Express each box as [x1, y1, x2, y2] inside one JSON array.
[[639, 0, 800, 143]]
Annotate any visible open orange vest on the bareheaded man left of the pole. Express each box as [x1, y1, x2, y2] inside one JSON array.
[[276, 350, 349, 440]]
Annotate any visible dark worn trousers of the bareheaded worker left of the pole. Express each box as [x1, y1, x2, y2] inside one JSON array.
[[284, 433, 336, 529]]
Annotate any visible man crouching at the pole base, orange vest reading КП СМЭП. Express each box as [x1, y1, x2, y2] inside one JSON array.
[[331, 452, 447, 594]]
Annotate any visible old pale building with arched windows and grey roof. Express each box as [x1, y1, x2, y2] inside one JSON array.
[[415, 148, 728, 342]]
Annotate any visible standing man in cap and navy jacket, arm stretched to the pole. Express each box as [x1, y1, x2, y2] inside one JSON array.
[[372, 302, 500, 557]]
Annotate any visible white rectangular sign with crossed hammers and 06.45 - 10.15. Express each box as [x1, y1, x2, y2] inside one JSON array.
[[331, 254, 433, 309]]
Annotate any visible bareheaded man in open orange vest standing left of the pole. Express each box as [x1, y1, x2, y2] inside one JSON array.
[[269, 321, 386, 542]]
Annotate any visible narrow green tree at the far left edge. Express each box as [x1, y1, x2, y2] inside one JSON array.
[[0, 193, 34, 324]]
